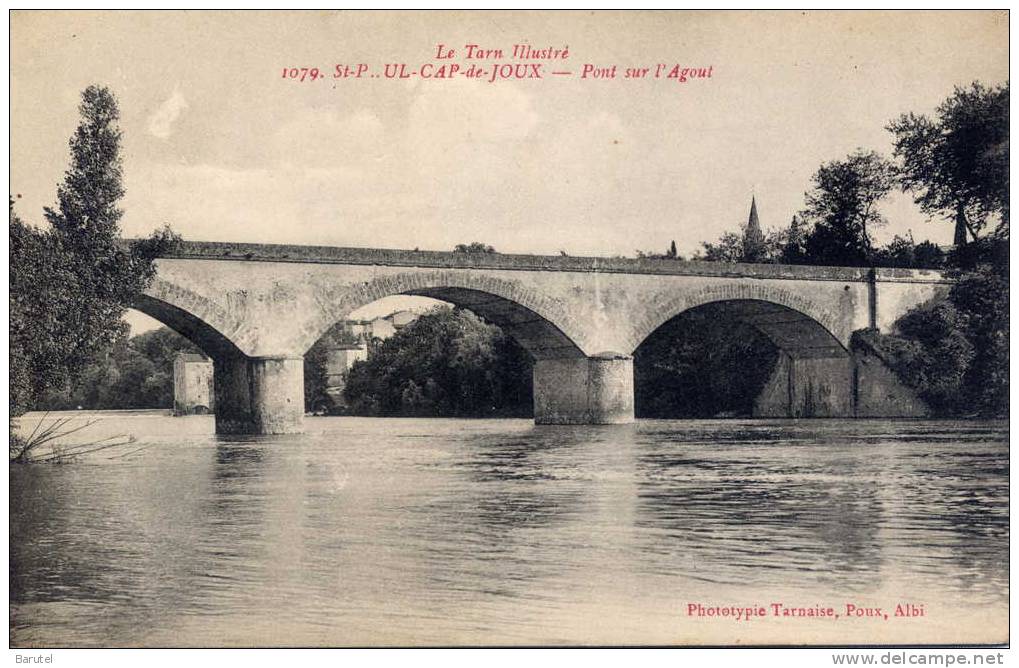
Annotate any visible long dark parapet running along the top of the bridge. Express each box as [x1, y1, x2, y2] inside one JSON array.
[[131, 241, 948, 283]]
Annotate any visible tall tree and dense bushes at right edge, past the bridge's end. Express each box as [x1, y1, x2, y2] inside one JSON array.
[[851, 84, 1009, 416]]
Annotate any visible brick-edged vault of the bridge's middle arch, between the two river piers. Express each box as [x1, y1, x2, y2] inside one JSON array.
[[298, 271, 585, 359]]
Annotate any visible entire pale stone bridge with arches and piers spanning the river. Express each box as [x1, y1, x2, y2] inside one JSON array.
[[136, 242, 945, 434]]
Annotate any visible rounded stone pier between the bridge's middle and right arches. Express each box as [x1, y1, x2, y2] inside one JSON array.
[[534, 355, 634, 425]]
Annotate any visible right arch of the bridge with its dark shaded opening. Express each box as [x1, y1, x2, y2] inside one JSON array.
[[634, 284, 854, 418]]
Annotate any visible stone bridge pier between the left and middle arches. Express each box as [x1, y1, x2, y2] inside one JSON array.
[[213, 355, 305, 434]]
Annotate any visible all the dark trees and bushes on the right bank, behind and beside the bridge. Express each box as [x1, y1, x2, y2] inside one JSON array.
[[652, 82, 1009, 416]]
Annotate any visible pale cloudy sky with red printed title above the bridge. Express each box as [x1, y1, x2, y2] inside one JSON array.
[[10, 11, 1008, 334]]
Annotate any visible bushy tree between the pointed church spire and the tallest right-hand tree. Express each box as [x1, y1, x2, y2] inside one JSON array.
[[800, 149, 895, 266]]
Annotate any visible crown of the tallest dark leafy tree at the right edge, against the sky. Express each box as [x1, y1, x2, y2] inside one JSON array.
[[887, 82, 1009, 245]]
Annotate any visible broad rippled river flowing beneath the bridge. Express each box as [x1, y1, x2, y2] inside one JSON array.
[[10, 412, 1009, 647]]
